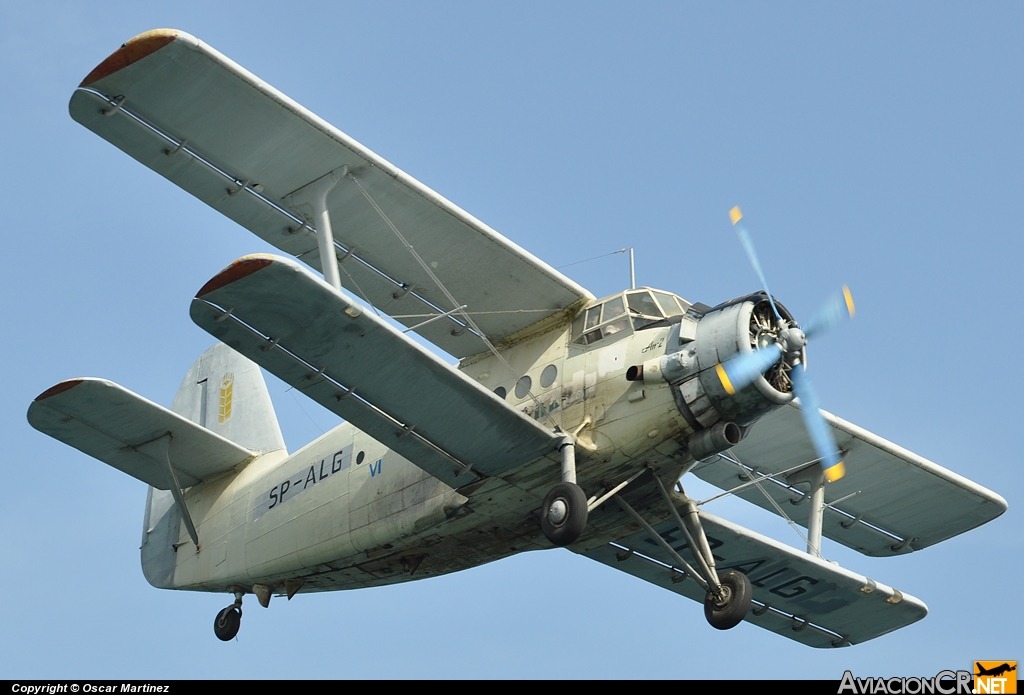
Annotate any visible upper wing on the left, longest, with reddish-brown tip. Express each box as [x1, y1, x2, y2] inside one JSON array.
[[70, 30, 593, 357]]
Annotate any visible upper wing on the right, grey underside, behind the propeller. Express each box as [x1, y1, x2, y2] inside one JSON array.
[[693, 404, 1007, 556]]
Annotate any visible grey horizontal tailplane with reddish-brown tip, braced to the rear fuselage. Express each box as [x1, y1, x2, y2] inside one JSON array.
[[29, 379, 255, 490]]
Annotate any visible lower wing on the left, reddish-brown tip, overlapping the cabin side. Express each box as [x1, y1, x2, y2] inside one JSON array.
[[191, 255, 560, 487]]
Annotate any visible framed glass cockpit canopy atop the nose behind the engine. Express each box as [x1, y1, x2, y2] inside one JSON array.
[[571, 288, 690, 345]]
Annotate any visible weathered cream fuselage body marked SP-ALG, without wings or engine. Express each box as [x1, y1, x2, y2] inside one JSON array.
[[142, 313, 688, 592]]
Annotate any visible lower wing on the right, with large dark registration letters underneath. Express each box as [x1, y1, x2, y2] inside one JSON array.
[[584, 511, 928, 648]]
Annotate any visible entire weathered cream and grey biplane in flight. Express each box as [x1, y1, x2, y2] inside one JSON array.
[[29, 30, 1007, 647]]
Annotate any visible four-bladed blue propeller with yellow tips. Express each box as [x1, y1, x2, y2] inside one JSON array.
[[715, 207, 854, 482]]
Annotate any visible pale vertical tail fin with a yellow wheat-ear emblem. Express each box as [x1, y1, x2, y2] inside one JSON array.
[[171, 343, 285, 453]]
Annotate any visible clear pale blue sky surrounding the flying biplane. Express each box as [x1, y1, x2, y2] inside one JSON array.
[[0, 1, 1024, 679]]
